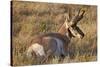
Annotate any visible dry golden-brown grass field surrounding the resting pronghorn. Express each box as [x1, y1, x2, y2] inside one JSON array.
[[11, 1, 97, 65]]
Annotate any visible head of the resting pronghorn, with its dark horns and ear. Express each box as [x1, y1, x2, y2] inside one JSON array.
[[65, 10, 85, 38]]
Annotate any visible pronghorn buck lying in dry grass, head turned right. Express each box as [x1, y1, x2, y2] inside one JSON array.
[[26, 10, 85, 62]]
